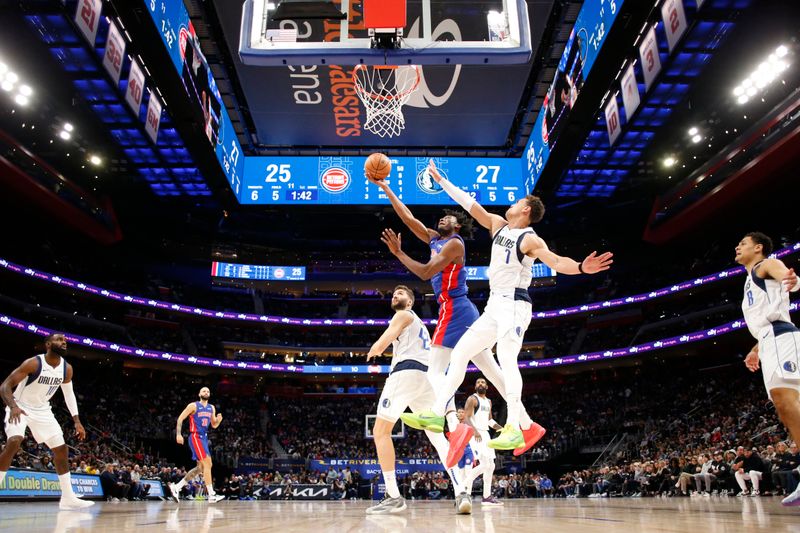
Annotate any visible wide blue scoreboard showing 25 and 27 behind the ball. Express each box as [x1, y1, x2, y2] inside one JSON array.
[[239, 156, 527, 205]]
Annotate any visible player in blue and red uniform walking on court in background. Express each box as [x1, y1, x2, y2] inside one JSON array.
[[169, 387, 222, 503]]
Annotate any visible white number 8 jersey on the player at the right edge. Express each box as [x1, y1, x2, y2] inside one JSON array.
[[742, 263, 792, 340]]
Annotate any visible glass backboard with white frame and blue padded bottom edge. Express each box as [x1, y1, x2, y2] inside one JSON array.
[[239, 0, 531, 66]]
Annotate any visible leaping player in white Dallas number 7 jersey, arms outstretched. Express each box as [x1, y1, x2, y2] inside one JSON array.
[[400, 160, 612, 460]]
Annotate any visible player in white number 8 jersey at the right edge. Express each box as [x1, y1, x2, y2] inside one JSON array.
[[736, 232, 800, 506]]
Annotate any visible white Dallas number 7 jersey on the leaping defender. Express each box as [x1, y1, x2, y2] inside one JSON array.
[[489, 226, 536, 292]]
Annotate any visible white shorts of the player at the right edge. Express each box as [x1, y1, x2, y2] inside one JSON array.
[[758, 322, 800, 398]]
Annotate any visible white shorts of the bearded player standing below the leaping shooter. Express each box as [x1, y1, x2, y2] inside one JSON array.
[[376, 369, 436, 423]]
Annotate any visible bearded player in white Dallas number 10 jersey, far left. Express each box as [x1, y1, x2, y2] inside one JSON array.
[[0, 333, 94, 509]]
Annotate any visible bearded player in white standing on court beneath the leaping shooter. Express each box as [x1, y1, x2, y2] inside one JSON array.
[[367, 285, 472, 514]]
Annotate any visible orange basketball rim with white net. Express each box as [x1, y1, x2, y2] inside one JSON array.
[[353, 65, 421, 137]]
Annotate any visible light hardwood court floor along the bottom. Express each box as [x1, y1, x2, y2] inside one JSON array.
[[0, 497, 800, 533]]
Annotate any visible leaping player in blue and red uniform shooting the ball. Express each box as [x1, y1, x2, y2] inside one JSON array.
[[367, 176, 545, 466]]
